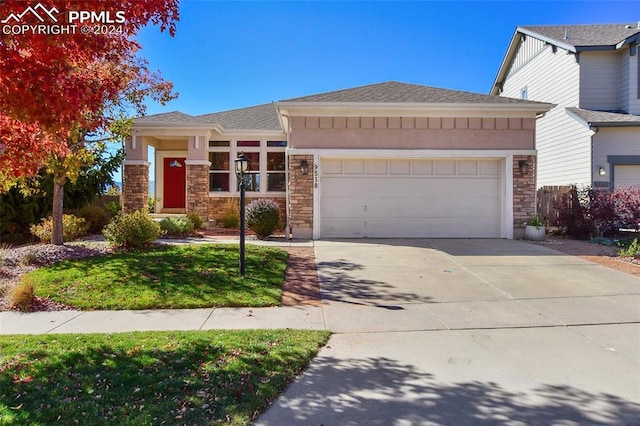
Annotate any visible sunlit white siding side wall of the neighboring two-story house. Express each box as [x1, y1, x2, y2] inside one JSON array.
[[501, 37, 591, 187]]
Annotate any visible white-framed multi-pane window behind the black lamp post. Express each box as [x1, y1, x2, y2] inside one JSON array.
[[209, 140, 287, 193]]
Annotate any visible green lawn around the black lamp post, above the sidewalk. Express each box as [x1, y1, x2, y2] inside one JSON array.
[[26, 244, 287, 310]]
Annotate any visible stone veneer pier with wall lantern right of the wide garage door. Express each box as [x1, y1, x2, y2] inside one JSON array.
[[513, 155, 536, 238]]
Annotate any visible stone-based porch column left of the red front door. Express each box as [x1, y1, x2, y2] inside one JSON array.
[[122, 136, 150, 213]]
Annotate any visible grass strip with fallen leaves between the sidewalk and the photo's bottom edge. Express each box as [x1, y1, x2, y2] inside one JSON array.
[[0, 330, 329, 425]]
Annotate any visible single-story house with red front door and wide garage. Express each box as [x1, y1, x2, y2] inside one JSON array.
[[123, 82, 553, 239]]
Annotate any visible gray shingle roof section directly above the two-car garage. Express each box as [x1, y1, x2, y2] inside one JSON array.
[[281, 81, 536, 104]]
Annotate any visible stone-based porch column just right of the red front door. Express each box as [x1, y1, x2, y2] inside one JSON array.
[[185, 136, 211, 222]]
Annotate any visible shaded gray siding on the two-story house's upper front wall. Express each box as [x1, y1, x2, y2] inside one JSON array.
[[578, 51, 628, 111]]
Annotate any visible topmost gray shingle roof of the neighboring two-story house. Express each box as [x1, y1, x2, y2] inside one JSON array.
[[518, 23, 640, 48]]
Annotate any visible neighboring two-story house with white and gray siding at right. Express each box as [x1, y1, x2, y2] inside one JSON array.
[[491, 23, 640, 188]]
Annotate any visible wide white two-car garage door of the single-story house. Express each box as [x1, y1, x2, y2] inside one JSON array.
[[320, 159, 502, 238]]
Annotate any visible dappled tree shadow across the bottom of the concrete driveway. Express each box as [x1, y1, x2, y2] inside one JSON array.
[[257, 357, 640, 425]]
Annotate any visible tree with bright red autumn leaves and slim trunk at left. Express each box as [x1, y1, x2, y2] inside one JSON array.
[[0, 0, 179, 244]]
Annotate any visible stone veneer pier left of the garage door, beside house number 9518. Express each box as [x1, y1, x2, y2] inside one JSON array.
[[288, 155, 314, 239]]
